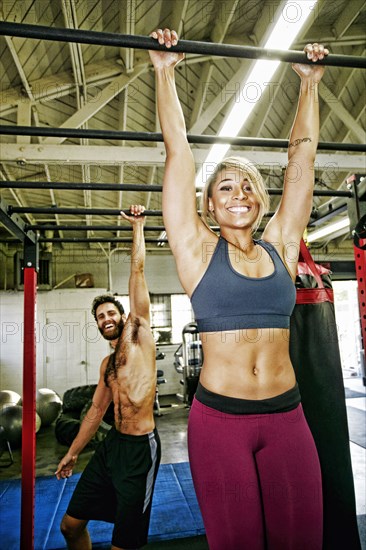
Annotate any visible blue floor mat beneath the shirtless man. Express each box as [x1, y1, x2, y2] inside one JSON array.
[[0, 462, 205, 550]]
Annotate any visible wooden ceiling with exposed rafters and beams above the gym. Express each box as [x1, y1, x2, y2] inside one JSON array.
[[0, 0, 366, 256]]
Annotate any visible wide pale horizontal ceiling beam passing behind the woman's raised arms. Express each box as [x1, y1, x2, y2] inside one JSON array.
[[1, 143, 365, 171]]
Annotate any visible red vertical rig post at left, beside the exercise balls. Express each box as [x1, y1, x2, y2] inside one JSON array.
[[20, 267, 37, 550]]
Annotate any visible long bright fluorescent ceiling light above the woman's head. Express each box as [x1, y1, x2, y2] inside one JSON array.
[[196, 0, 317, 187]]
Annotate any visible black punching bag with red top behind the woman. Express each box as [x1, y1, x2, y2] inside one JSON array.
[[290, 241, 361, 550]]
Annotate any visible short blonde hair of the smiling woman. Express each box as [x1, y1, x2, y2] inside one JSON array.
[[201, 157, 270, 233]]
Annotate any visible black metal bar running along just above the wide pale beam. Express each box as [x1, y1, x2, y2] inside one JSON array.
[[0, 125, 366, 152]]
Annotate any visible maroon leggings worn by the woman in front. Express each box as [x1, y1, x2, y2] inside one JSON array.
[[188, 398, 323, 550]]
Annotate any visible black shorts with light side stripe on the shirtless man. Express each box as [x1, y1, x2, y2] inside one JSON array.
[[66, 428, 161, 548]]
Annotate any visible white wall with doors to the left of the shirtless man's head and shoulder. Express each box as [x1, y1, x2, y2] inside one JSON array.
[[0, 288, 109, 394]]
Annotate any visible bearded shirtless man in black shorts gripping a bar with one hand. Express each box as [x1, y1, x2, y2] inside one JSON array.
[[55, 205, 160, 550]]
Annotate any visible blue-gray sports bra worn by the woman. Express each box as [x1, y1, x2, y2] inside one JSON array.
[[191, 237, 296, 332]]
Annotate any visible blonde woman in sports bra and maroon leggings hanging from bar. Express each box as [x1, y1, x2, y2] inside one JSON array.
[[150, 29, 328, 550]]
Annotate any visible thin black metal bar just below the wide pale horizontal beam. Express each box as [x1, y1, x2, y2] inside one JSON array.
[[0, 181, 353, 198]]
